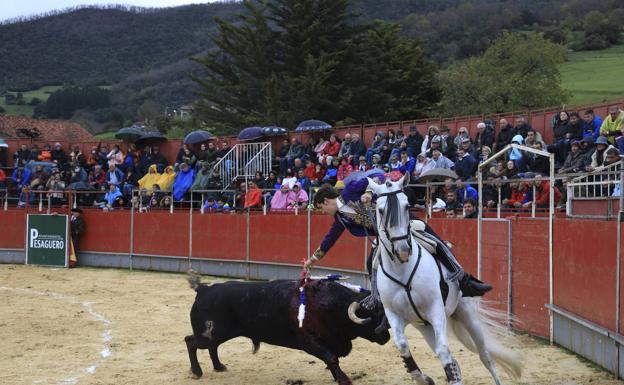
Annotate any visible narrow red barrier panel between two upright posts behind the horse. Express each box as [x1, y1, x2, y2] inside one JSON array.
[[511, 218, 549, 337]]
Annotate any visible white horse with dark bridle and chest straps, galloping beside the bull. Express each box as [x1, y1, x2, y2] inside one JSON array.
[[349, 174, 522, 385]]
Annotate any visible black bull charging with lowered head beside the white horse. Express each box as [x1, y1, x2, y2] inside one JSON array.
[[185, 276, 390, 385]]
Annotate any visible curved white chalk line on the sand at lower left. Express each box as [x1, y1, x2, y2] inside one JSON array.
[[0, 286, 113, 385]]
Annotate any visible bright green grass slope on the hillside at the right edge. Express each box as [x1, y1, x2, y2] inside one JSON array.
[[561, 45, 624, 105]]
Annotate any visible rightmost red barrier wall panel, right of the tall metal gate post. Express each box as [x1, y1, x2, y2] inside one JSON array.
[[553, 220, 617, 330]]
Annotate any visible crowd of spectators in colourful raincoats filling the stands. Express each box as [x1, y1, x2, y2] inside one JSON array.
[[0, 106, 624, 218]]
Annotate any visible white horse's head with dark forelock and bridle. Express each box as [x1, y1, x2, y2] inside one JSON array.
[[368, 173, 412, 262]]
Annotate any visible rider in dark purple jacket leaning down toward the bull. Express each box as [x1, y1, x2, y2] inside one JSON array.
[[304, 172, 492, 328]]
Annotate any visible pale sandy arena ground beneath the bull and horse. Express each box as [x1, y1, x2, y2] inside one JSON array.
[[0, 265, 622, 385]]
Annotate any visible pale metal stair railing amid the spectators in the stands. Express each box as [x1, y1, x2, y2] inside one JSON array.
[[213, 142, 273, 190]]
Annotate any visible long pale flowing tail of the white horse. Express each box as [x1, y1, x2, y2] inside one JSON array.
[[449, 297, 524, 379]]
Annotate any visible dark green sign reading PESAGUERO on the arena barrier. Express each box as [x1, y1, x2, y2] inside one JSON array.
[[26, 214, 69, 267]]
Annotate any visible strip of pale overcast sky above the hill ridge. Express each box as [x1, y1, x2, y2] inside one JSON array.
[[0, 0, 215, 20]]
